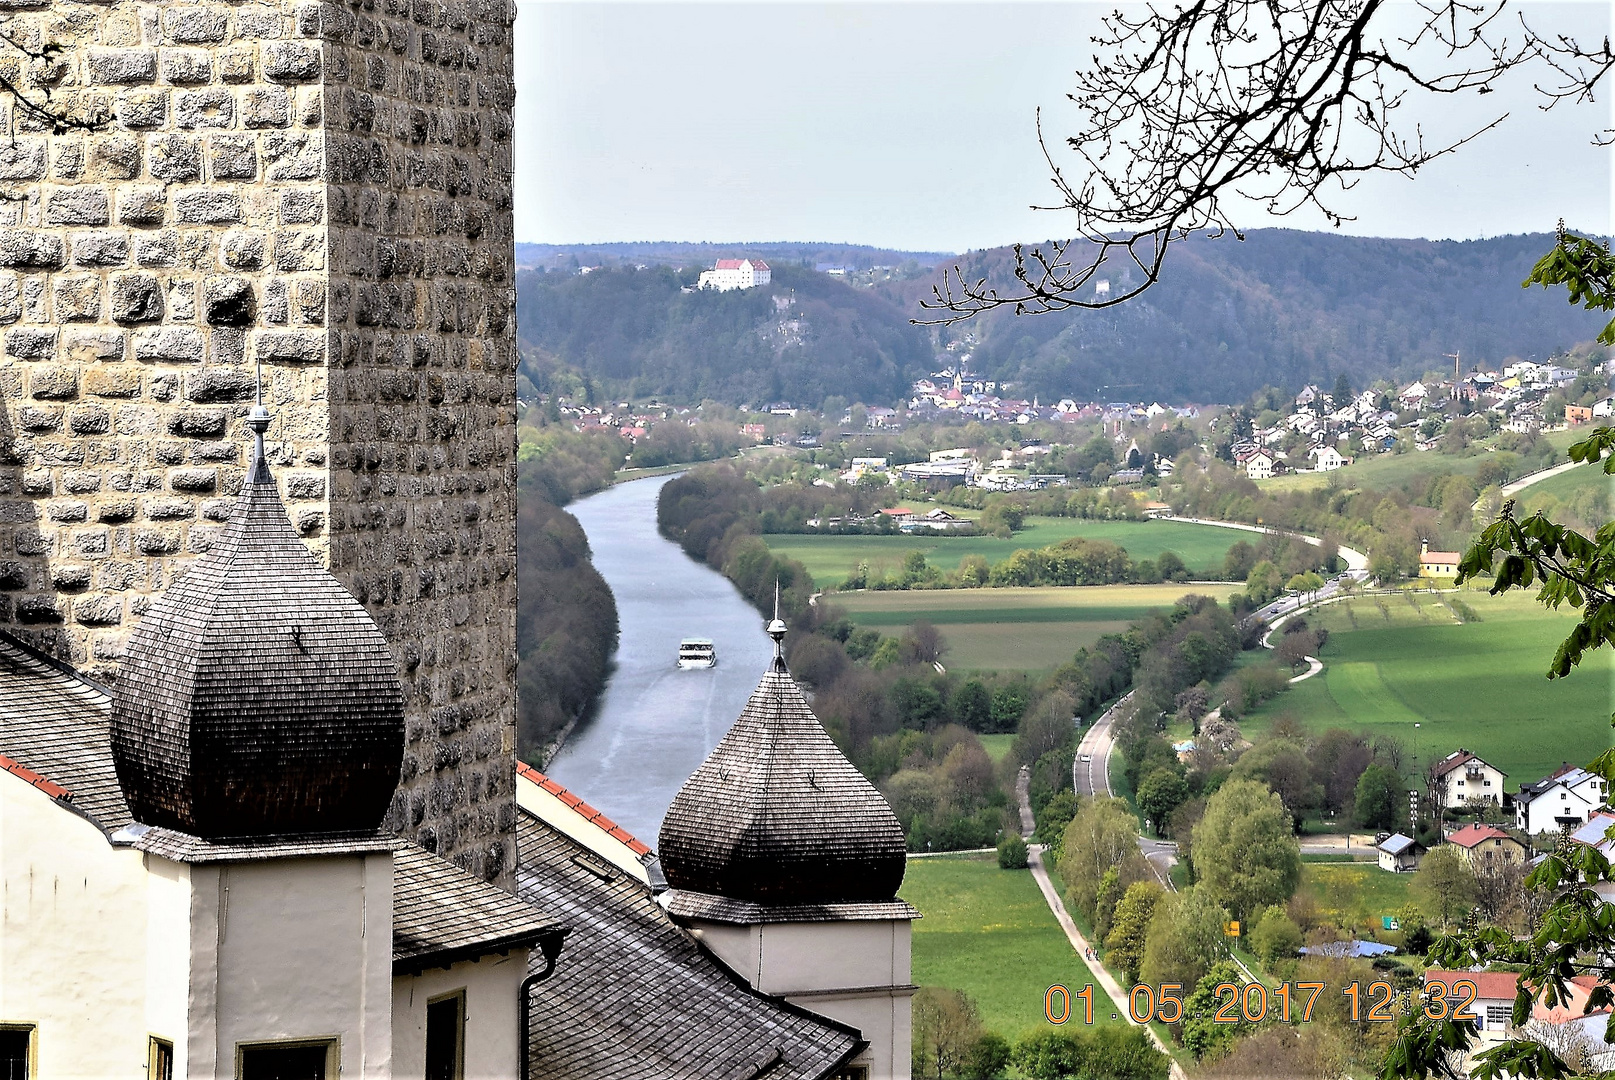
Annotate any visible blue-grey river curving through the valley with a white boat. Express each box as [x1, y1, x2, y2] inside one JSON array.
[[547, 476, 774, 848]]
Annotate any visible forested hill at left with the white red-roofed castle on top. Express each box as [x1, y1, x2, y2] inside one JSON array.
[[517, 265, 932, 407]]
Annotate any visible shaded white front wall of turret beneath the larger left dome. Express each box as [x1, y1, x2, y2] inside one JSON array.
[[186, 852, 392, 1080]]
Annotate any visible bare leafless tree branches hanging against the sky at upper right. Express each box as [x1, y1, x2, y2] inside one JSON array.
[[916, 0, 1615, 324]]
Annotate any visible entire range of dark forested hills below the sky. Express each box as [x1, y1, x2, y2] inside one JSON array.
[[518, 229, 1602, 405]]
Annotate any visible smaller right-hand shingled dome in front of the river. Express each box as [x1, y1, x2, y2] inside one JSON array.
[[659, 618, 906, 906]]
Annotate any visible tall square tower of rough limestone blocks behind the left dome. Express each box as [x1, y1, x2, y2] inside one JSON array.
[[0, 0, 515, 886]]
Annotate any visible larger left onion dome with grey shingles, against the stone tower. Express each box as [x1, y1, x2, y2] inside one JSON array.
[[111, 382, 404, 839]]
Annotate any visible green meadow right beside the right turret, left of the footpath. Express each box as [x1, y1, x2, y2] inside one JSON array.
[[901, 856, 1126, 1041]]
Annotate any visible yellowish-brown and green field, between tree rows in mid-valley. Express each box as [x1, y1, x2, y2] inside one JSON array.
[[828, 584, 1237, 672]]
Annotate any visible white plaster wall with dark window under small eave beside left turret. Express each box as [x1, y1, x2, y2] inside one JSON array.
[[392, 949, 528, 1080]]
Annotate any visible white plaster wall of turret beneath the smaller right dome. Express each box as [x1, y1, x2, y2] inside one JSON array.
[[691, 919, 912, 1080]]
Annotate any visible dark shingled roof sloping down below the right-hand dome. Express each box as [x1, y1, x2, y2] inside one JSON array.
[[517, 810, 864, 1080]]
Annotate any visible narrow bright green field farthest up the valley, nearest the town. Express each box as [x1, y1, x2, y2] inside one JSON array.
[[762, 517, 1250, 588]]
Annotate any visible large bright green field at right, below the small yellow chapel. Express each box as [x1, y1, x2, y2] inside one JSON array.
[[1242, 591, 1615, 788]]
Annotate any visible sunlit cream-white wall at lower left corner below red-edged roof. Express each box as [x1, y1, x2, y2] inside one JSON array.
[[0, 772, 189, 1080]]
